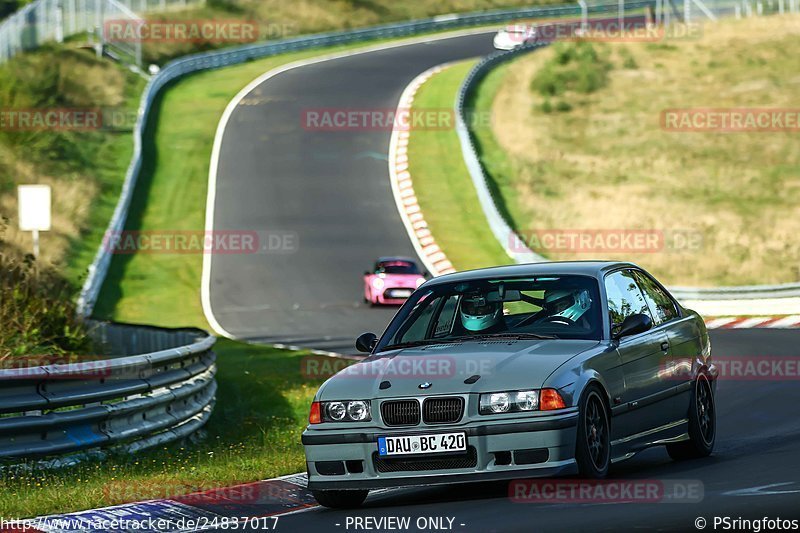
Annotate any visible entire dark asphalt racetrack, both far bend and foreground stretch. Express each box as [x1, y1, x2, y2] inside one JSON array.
[[210, 27, 800, 532]]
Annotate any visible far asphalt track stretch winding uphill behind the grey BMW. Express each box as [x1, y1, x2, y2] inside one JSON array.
[[210, 33, 493, 352]]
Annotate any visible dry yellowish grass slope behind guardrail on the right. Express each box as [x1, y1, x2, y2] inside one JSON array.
[[472, 15, 800, 286]]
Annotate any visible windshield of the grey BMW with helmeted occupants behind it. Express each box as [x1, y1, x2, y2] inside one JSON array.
[[377, 276, 602, 351]]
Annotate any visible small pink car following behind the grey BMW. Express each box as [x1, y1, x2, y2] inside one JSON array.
[[364, 257, 427, 305]]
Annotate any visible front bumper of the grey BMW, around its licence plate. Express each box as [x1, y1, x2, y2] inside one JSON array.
[[302, 410, 578, 490]]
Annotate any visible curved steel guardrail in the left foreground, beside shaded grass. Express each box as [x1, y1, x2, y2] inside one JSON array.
[[0, 323, 217, 460]]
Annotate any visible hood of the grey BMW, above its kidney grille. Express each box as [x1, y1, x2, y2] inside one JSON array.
[[317, 340, 599, 400]]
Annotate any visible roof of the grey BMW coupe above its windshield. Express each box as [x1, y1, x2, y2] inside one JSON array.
[[426, 261, 639, 286]]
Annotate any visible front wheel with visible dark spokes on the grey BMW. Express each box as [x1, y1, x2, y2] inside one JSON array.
[[575, 386, 611, 479]]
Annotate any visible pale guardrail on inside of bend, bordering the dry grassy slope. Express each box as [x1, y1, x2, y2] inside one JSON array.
[[455, 5, 800, 316]]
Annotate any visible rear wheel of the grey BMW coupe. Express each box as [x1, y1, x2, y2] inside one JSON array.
[[667, 374, 717, 461]]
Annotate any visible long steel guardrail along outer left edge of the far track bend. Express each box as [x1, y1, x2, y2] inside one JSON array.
[[78, 0, 653, 316]]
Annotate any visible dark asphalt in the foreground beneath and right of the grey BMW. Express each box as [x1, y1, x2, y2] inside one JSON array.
[[227, 330, 800, 533]]
